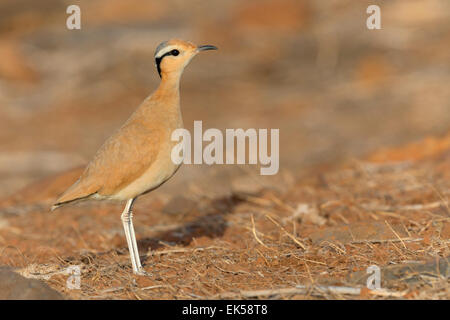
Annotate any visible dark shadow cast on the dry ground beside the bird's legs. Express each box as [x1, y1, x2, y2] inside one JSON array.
[[138, 196, 242, 263]]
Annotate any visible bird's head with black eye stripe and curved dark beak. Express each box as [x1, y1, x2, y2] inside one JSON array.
[[155, 39, 217, 78]]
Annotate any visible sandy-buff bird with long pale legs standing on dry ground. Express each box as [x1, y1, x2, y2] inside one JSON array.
[[51, 39, 217, 275]]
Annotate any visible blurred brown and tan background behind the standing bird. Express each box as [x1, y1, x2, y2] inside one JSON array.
[[0, 0, 450, 195]]
